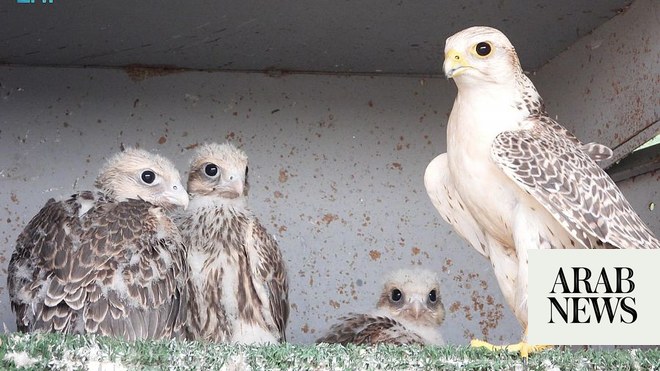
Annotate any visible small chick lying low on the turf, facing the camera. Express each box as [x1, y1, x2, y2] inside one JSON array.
[[316, 269, 445, 345]]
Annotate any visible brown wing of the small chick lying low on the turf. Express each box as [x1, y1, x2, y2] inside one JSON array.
[[316, 313, 425, 345]]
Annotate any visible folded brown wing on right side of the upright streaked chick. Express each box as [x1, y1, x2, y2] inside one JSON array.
[[248, 218, 289, 341]]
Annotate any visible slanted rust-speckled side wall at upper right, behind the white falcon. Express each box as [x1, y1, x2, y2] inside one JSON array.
[[532, 0, 660, 167]]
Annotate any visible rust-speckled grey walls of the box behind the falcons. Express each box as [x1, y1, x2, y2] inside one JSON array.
[[0, 1, 660, 343]]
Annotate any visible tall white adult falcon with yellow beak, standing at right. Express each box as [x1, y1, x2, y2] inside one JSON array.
[[424, 27, 660, 357]]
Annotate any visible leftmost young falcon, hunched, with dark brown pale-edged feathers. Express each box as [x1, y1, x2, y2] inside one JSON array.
[[7, 149, 188, 340]]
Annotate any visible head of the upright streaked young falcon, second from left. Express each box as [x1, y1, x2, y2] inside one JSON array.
[[188, 143, 249, 200]]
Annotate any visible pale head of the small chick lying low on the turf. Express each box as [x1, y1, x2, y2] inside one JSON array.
[[377, 269, 445, 326]]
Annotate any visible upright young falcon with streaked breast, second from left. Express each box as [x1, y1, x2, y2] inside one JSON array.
[[177, 143, 289, 343]]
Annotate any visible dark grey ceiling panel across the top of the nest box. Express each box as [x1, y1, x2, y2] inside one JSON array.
[[0, 0, 631, 74]]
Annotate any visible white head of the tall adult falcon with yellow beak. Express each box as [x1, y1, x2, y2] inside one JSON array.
[[443, 26, 522, 86]]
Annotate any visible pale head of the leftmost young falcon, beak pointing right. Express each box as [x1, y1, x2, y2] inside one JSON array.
[[96, 148, 189, 210]]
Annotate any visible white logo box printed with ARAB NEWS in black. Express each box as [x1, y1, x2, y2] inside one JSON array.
[[527, 249, 660, 345]]
